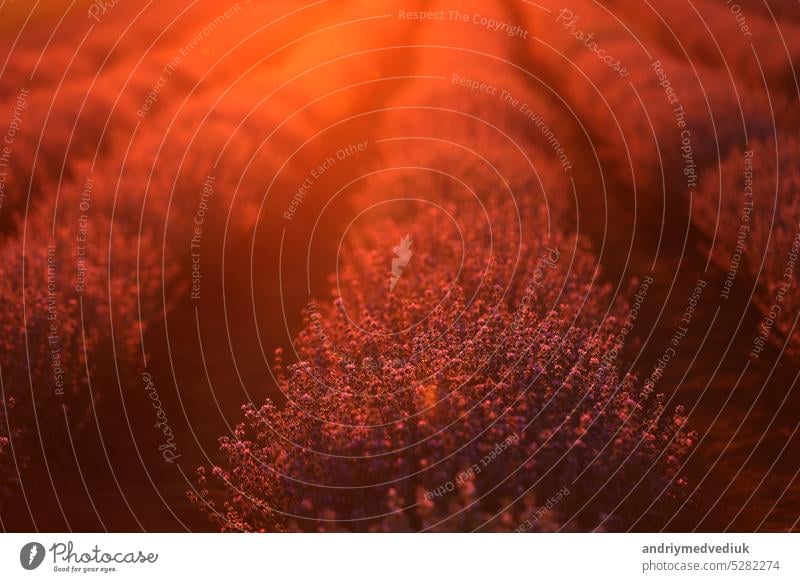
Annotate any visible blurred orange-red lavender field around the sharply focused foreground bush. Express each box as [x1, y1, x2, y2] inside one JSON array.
[[0, 0, 800, 531]]
